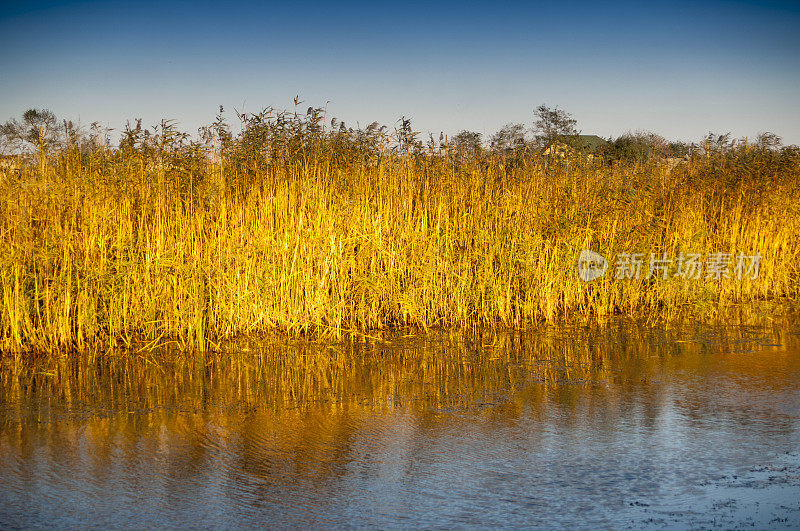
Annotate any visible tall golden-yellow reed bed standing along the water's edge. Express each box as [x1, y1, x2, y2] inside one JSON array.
[[0, 114, 800, 352]]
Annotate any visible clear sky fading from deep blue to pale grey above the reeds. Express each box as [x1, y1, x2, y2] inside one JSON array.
[[0, 0, 800, 144]]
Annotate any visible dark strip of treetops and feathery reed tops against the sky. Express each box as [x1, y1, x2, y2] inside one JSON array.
[[0, 103, 797, 170]]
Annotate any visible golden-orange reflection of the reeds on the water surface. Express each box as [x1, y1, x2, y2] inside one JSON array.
[[0, 320, 798, 454]]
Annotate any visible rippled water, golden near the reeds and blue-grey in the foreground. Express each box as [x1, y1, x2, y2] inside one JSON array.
[[0, 319, 800, 528]]
